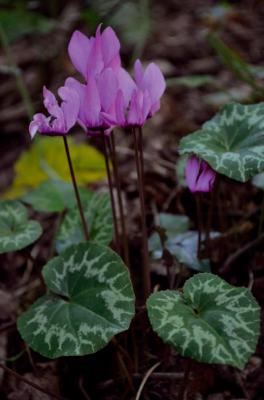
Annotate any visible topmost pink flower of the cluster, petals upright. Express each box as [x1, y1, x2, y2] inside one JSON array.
[[68, 25, 121, 81]]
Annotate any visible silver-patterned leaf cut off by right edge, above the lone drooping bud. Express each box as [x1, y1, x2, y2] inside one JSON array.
[[179, 103, 264, 182]]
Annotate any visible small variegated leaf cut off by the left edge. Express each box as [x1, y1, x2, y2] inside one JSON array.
[[0, 200, 42, 253]]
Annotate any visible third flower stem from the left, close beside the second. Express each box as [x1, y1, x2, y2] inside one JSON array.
[[109, 132, 130, 266]]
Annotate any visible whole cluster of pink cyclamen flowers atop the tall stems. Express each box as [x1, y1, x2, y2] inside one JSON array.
[[29, 26, 165, 138]]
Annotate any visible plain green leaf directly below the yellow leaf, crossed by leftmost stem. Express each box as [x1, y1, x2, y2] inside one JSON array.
[[22, 180, 91, 212]]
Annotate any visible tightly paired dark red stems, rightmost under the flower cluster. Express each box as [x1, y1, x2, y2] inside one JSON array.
[[132, 128, 151, 299]]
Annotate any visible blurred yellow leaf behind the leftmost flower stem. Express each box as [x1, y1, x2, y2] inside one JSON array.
[[4, 137, 106, 199]]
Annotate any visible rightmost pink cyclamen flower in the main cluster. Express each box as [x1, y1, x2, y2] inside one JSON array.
[[103, 60, 166, 127]]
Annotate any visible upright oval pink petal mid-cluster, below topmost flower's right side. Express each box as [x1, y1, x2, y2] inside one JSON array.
[[97, 68, 118, 112]]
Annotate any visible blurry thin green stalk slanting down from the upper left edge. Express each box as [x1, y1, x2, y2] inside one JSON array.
[[0, 24, 34, 119]]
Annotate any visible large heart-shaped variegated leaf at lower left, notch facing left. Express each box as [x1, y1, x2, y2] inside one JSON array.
[[18, 242, 135, 358]]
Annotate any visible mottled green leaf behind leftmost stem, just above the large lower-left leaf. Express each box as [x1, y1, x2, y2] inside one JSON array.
[[56, 193, 113, 253]]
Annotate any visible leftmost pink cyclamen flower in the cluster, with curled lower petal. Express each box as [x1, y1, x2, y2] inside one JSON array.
[[29, 86, 80, 139]]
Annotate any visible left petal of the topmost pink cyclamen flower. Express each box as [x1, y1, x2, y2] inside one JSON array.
[[68, 31, 91, 79]]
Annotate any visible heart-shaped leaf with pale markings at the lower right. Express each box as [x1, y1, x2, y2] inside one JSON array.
[[147, 273, 260, 369]]
